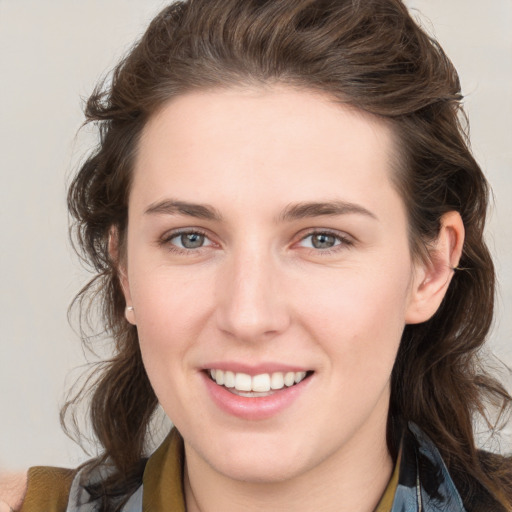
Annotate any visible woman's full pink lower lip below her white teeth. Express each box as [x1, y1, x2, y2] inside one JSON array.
[[201, 372, 311, 421]]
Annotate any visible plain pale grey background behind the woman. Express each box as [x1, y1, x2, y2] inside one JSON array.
[[0, 0, 512, 469]]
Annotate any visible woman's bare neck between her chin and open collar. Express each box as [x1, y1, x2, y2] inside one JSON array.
[[184, 412, 393, 512]]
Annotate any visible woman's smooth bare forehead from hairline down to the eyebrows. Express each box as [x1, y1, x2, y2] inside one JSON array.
[[133, 86, 400, 216]]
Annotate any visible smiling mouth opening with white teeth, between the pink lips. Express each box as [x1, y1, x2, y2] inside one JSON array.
[[206, 368, 313, 398]]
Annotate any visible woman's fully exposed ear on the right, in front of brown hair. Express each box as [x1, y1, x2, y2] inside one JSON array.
[[405, 211, 464, 324]]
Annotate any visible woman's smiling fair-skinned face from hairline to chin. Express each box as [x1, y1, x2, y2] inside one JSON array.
[[123, 86, 424, 481]]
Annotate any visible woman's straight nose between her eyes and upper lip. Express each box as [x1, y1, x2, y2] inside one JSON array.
[[216, 245, 290, 342]]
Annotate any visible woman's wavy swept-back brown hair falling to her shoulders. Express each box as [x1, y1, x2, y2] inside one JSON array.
[[62, 0, 512, 510]]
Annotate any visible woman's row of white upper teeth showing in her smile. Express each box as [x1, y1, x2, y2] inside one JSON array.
[[210, 370, 306, 392]]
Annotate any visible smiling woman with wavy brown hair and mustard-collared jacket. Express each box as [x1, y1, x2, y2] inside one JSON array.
[[2, 0, 512, 512]]
